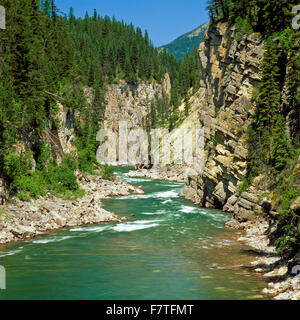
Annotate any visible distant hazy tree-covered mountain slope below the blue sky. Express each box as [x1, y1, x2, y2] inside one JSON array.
[[159, 23, 208, 59]]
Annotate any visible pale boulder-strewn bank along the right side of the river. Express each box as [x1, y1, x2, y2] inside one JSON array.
[[126, 162, 300, 300]]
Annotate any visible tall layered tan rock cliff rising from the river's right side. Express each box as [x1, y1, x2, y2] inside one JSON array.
[[181, 23, 264, 221]]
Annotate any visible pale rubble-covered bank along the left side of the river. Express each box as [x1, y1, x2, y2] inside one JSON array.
[[0, 175, 143, 244]]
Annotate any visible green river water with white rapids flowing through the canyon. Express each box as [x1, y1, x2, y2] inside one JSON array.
[[0, 169, 266, 300]]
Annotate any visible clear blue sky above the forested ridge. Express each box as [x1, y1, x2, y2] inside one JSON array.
[[55, 0, 208, 46]]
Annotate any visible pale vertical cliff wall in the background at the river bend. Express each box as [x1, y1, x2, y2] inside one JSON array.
[[97, 73, 171, 165]]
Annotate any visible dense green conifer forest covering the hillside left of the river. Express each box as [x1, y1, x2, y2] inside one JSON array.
[[0, 0, 201, 199]]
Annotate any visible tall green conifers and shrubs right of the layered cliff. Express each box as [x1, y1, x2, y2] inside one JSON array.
[[245, 32, 300, 254]]
